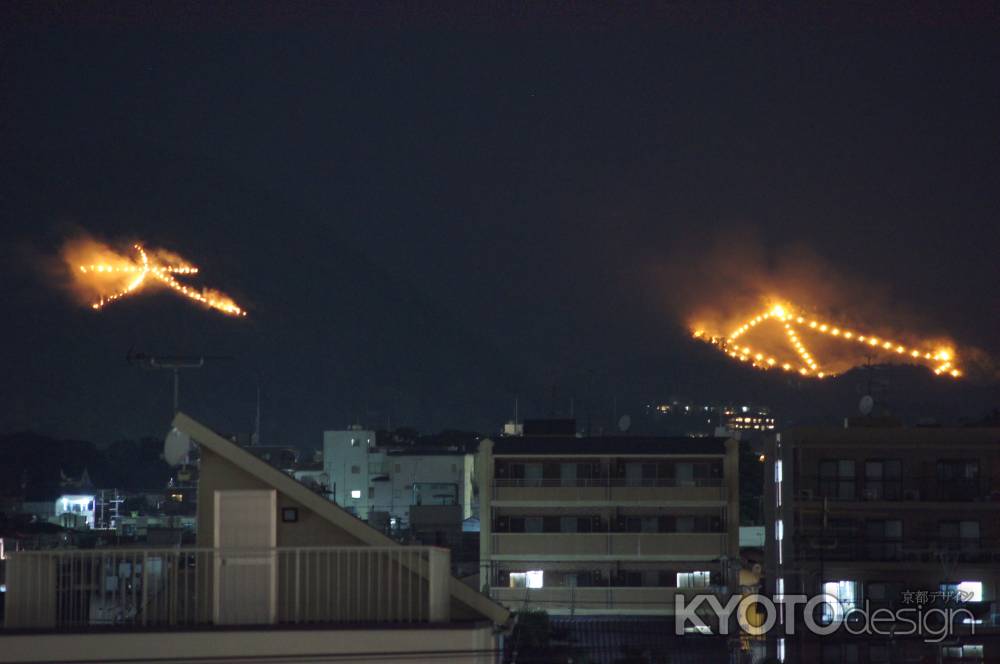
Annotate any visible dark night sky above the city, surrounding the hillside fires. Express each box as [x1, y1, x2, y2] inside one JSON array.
[[0, 5, 1000, 445]]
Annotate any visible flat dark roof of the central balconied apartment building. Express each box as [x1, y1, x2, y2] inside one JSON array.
[[493, 436, 726, 456]]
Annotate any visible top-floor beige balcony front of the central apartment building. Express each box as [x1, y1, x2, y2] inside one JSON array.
[[493, 478, 726, 504]]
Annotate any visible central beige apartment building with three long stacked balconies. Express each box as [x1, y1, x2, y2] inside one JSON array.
[[479, 436, 739, 615]]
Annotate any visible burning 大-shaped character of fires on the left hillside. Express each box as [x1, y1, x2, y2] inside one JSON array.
[[77, 244, 247, 316]]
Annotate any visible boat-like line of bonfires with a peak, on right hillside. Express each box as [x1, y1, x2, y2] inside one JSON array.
[[692, 304, 962, 378]]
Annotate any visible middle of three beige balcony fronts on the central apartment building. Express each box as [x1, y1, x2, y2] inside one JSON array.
[[491, 532, 728, 560]]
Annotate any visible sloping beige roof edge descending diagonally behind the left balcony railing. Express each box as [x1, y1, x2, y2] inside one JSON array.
[[173, 413, 510, 625]]
